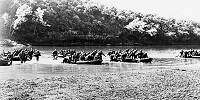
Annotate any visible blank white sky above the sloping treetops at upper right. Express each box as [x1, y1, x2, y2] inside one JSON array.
[[92, 0, 200, 22]]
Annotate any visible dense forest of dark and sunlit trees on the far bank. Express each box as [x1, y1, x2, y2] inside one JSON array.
[[0, 0, 200, 46]]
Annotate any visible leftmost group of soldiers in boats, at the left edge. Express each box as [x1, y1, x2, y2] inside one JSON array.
[[1, 48, 41, 63]]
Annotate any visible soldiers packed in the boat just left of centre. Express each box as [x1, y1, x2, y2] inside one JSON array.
[[52, 49, 105, 63]]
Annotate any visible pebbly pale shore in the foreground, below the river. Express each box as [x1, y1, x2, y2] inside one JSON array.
[[0, 69, 200, 100]]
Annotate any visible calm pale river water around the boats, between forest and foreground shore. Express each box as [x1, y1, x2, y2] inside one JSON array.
[[0, 45, 200, 80]]
